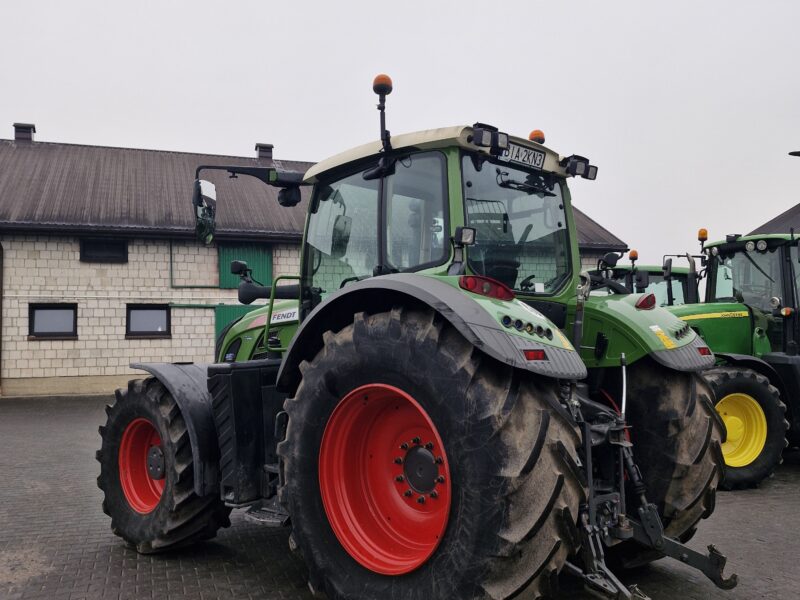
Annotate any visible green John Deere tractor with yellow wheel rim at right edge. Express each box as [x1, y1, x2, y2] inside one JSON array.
[[672, 230, 800, 488]]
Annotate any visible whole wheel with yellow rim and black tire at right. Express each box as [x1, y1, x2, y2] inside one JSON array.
[[703, 367, 789, 490]]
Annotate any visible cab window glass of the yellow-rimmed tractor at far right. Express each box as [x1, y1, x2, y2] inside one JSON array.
[[711, 248, 782, 313]]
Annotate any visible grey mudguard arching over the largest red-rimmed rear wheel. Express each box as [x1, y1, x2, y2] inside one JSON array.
[[278, 273, 586, 394]]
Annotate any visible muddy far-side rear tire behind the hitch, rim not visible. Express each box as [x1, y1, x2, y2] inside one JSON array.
[[609, 358, 725, 568]]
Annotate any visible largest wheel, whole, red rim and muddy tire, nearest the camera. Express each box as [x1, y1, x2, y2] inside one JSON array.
[[278, 308, 585, 600]]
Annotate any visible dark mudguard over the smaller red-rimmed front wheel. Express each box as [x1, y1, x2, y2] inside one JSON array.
[[131, 363, 219, 496]]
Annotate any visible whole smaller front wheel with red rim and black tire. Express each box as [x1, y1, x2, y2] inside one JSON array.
[[97, 377, 230, 554]]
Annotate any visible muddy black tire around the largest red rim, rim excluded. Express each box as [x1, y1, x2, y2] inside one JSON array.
[[278, 308, 585, 600]]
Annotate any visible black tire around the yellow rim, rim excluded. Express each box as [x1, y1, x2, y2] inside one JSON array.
[[703, 367, 789, 490]]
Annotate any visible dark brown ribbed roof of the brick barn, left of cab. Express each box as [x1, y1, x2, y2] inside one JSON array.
[[0, 140, 312, 240]]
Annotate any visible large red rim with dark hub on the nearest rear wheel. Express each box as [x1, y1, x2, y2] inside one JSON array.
[[319, 383, 451, 575]]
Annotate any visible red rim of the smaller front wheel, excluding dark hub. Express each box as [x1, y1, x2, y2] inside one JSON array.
[[119, 418, 165, 514]]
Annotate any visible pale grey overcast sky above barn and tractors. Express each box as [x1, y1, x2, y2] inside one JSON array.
[[0, 0, 800, 262]]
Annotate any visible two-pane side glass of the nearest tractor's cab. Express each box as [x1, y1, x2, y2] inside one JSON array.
[[305, 152, 449, 296]]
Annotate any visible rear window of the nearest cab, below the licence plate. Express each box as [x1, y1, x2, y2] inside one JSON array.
[[462, 155, 570, 294]]
